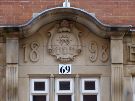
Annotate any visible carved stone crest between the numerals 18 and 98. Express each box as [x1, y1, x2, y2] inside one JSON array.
[[48, 20, 81, 63]]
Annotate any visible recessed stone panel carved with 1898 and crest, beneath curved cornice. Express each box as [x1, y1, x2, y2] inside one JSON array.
[[19, 19, 110, 65]]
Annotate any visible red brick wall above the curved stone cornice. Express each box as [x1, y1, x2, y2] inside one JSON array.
[[0, 0, 135, 26]]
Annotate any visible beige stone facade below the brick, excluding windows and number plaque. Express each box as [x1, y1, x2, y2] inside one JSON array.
[[0, 7, 135, 101]]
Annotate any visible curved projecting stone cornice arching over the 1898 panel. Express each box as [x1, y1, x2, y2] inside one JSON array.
[[18, 7, 131, 38]]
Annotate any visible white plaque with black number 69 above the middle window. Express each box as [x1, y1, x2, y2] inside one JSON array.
[[59, 64, 71, 74]]
